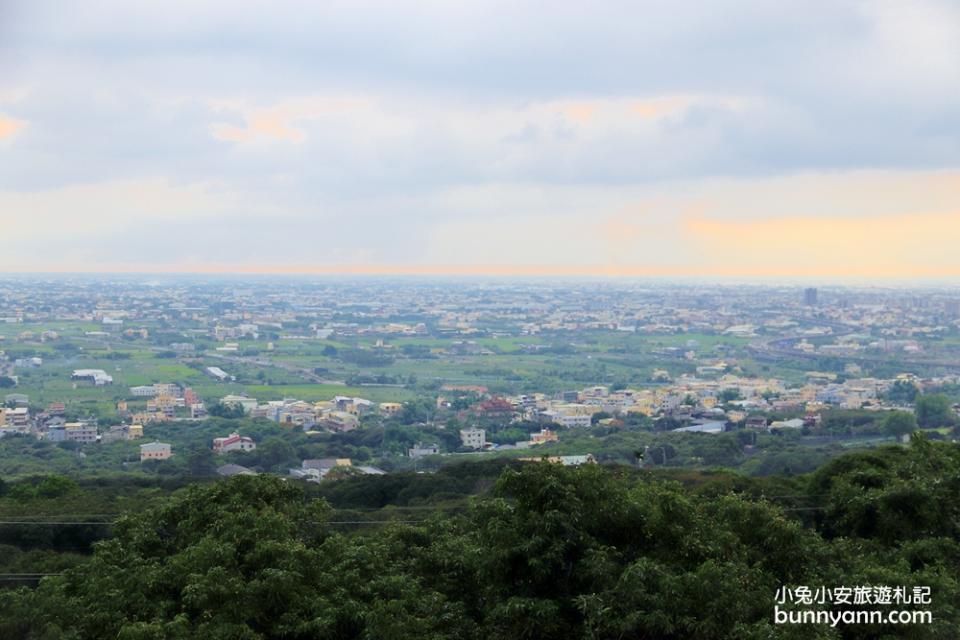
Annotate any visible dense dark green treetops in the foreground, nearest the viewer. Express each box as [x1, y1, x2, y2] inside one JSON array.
[[0, 438, 960, 640]]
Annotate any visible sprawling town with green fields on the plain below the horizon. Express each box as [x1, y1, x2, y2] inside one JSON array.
[[0, 278, 960, 481]]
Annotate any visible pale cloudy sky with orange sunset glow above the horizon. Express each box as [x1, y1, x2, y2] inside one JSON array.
[[0, 0, 960, 279]]
